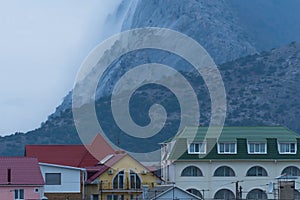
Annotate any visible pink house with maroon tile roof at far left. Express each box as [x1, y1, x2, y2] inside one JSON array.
[[0, 157, 44, 200]]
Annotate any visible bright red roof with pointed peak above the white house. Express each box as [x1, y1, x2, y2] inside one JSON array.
[[25, 134, 114, 167]]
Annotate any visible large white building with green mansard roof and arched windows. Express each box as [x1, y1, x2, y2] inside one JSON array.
[[161, 127, 300, 199]]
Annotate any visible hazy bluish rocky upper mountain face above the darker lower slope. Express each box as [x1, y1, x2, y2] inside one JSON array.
[[50, 0, 300, 118]]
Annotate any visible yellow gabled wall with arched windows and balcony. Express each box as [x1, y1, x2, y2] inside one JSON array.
[[87, 155, 158, 200]]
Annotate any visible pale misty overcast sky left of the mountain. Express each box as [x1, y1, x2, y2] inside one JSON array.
[[0, 0, 120, 135]]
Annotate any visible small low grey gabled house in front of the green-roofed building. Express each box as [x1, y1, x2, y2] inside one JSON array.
[[138, 185, 201, 200]]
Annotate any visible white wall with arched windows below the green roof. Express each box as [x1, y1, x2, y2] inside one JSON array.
[[170, 160, 300, 198]]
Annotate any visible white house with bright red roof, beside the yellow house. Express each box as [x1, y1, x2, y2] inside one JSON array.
[[25, 134, 114, 200]]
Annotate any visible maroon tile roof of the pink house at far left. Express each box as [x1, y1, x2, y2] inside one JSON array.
[[0, 157, 44, 185]]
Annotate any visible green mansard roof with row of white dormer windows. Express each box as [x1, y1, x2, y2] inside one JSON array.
[[166, 126, 300, 159]]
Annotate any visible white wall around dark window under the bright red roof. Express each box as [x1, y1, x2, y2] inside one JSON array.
[[40, 164, 81, 193]]
